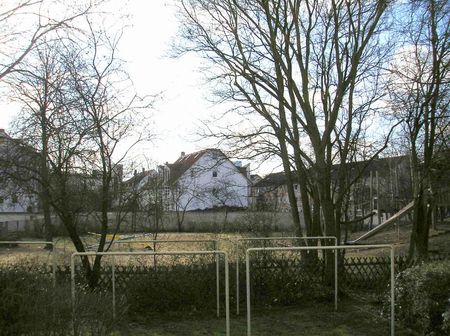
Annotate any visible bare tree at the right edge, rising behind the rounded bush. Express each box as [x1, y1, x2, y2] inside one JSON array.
[[389, 0, 450, 262]]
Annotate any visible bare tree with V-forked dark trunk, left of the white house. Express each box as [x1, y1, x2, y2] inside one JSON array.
[[3, 20, 154, 287]]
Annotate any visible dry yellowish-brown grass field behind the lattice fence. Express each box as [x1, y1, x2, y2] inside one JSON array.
[[0, 223, 450, 264]]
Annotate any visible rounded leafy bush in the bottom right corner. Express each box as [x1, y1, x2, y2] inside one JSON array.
[[395, 260, 450, 335]]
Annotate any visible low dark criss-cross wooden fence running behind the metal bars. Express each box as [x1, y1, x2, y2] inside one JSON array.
[[0, 253, 450, 306]]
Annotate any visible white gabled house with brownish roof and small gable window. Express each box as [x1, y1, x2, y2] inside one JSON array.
[[159, 149, 251, 211]]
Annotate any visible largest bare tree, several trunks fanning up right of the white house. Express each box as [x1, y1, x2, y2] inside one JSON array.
[[178, 0, 389, 239]]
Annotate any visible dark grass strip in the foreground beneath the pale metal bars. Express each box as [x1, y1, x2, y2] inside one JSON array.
[[115, 304, 414, 336]]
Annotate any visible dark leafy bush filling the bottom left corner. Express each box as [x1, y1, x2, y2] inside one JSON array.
[[0, 264, 121, 336]]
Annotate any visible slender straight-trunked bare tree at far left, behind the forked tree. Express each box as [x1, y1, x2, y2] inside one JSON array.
[[2, 42, 73, 247]]
